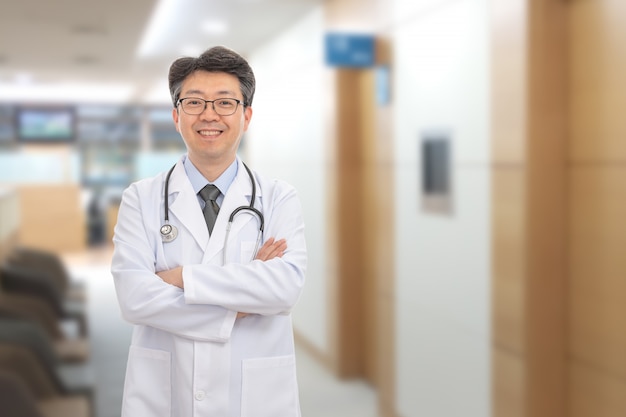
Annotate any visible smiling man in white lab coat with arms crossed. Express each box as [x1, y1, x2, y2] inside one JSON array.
[[111, 47, 307, 417]]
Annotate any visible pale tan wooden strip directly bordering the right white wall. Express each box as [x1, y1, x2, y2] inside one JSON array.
[[490, 0, 527, 417]]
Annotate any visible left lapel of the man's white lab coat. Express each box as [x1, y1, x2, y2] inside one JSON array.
[[169, 162, 209, 249]]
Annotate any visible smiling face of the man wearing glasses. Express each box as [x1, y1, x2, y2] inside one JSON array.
[[172, 71, 252, 174]]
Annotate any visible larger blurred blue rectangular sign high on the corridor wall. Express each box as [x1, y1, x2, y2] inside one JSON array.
[[325, 33, 375, 68]]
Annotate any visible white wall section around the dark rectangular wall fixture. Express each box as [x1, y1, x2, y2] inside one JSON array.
[[392, 0, 490, 417]]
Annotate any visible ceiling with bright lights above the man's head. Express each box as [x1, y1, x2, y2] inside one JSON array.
[[0, 0, 323, 102]]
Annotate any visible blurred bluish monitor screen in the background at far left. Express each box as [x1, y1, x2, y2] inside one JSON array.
[[16, 106, 75, 143]]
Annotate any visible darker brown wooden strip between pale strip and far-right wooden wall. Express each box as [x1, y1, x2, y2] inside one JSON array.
[[525, 0, 567, 417]]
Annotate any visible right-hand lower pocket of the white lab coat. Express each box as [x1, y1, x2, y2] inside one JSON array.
[[241, 355, 300, 417]]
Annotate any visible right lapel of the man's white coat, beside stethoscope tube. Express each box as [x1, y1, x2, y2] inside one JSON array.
[[204, 161, 259, 261]]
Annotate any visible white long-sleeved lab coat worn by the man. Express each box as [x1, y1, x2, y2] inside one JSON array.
[[112, 156, 306, 417]]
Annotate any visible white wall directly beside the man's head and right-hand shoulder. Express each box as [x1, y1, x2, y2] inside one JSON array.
[[242, 7, 331, 352]]
